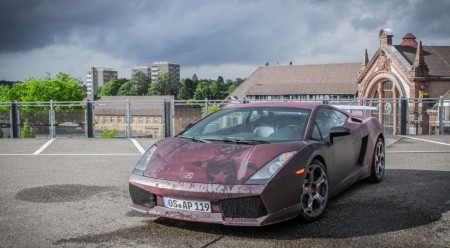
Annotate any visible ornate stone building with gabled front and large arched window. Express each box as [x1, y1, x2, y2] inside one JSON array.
[[356, 29, 450, 134]]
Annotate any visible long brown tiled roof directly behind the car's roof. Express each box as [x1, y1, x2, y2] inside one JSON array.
[[230, 63, 361, 98]]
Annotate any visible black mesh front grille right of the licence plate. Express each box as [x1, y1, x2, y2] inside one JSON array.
[[219, 196, 267, 218]]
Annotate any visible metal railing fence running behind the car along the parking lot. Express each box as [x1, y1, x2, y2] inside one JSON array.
[[0, 97, 450, 138]]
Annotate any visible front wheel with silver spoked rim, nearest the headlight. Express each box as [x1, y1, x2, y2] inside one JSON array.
[[299, 160, 328, 222]]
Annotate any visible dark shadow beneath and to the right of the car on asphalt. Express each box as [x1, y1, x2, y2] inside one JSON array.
[[149, 170, 450, 239]]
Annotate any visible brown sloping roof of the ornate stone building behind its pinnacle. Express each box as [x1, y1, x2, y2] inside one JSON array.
[[394, 45, 450, 76]]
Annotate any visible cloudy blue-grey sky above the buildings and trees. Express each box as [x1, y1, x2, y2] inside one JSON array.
[[0, 0, 450, 81]]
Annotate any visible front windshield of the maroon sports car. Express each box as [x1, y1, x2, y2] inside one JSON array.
[[178, 106, 311, 144]]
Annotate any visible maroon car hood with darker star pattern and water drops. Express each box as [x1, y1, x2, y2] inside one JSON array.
[[144, 137, 301, 185]]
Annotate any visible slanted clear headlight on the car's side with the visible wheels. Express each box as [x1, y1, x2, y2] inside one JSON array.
[[245, 152, 297, 184]]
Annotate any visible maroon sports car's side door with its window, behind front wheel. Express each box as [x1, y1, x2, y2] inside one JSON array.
[[316, 108, 358, 189]]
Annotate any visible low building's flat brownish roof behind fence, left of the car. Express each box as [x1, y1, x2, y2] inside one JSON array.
[[94, 96, 175, 116]]
